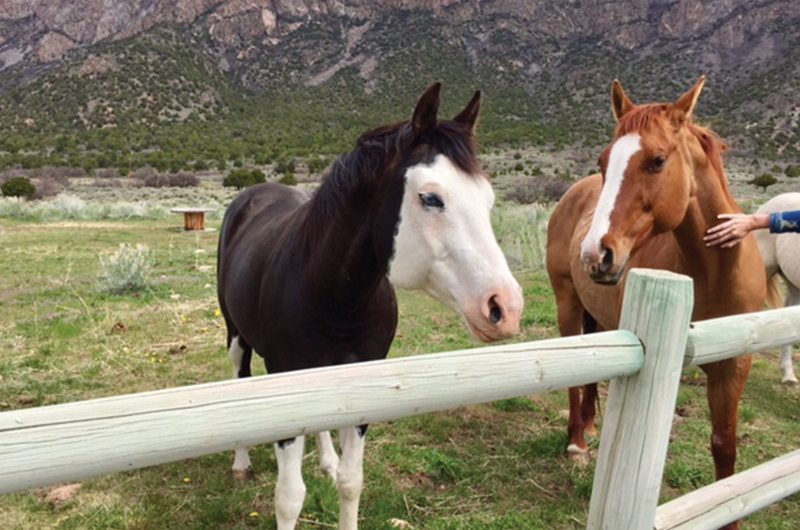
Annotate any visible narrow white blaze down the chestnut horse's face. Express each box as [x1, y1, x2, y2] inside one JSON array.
[[581, 133, 642, 261]]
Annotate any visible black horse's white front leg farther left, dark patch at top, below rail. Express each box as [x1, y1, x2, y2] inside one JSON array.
[[275, 436, 306, 530]]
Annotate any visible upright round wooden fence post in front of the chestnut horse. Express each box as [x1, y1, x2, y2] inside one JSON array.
[[587, 269, 694, 530]]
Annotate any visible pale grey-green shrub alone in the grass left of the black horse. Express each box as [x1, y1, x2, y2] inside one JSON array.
[[97, 243, 153, 294]]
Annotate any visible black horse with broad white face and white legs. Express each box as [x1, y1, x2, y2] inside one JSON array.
[[218, 83, 523, 529]]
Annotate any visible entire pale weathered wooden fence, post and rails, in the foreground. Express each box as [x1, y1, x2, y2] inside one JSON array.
[[0, 270, 800, 530]]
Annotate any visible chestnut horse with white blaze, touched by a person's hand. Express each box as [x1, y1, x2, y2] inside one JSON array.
[[547, 78, 767, 528]]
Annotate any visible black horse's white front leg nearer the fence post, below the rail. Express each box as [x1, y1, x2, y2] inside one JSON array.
[[336, 425, 367, 530]]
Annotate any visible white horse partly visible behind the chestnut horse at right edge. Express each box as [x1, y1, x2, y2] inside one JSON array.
[[755, 193, 800, 384]]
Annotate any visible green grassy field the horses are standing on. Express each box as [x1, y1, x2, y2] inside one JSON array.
[[0, 200, 800, 530]]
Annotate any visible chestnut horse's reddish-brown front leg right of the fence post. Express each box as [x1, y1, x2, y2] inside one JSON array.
[[701, 354, 752, 530]]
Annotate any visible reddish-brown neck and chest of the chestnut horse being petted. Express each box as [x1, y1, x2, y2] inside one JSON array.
[[674, 141, 761, 318]]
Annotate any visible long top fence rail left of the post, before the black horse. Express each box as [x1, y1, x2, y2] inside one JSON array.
[[0, 331, 644, 493]]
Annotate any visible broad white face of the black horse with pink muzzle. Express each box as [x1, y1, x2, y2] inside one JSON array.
[[389, 155, 523, 340]]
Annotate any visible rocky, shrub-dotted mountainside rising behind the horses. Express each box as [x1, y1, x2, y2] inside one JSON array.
[[0, 0, 800, 167]]
